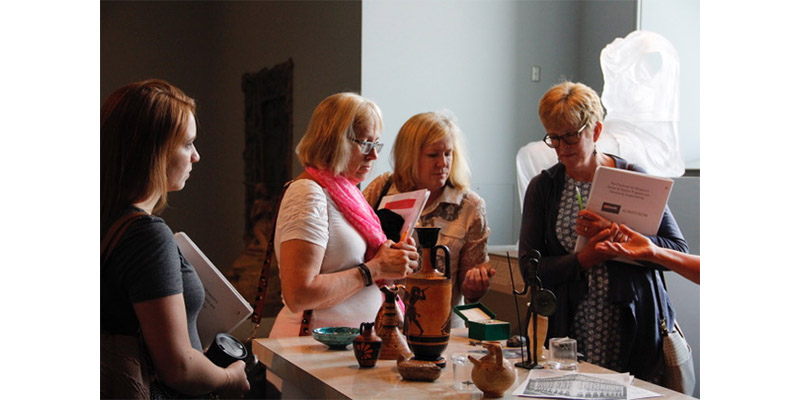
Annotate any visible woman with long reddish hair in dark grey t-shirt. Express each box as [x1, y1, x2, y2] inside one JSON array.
[[100, 79, 250, 398]]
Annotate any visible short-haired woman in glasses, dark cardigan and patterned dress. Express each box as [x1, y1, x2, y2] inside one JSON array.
[[519, 82, 688, 383]]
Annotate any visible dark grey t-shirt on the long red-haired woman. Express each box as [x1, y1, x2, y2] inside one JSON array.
[[100, 207, 205, 351]]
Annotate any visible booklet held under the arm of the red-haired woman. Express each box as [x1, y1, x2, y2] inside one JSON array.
[[175, 232, 253, 349]]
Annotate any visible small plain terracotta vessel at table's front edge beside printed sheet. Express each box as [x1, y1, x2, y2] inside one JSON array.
[[467, 342, 516, 397]]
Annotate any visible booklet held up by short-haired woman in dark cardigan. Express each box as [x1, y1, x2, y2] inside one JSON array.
[[568, 167, 673, 253]]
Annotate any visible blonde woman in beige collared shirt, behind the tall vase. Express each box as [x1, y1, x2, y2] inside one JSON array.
[[364, 112, 495, 328]]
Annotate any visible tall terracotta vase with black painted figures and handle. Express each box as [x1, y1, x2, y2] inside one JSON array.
[[404, 228, 453, 365]]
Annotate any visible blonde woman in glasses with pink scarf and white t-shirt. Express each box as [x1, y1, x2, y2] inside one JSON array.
[[270, 93, 418, 337]]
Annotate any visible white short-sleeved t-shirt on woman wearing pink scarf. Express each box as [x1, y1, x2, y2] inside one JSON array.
[[269, 179, 383, 337]]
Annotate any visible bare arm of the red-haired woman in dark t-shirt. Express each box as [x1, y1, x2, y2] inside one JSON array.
[[133, 294, 250, 397]]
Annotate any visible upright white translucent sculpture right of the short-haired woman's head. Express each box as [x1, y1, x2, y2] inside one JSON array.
[[598, 31, 685, 177]]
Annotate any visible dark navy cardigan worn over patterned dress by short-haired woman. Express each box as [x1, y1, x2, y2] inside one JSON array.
[[519, 155, 689, 380]]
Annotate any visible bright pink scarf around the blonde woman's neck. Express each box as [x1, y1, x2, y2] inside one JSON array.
[[306, 167, 386, 261]]
